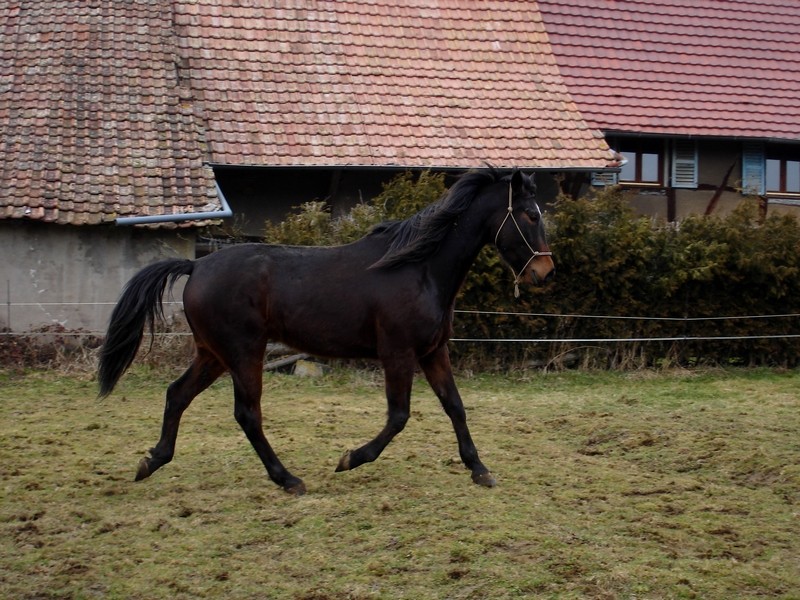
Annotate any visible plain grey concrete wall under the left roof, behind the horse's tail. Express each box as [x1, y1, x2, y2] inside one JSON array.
[[0, 221, 195, 332]]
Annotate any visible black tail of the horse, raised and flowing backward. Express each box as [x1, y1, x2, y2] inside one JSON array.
[[98, 258, 194, 397]]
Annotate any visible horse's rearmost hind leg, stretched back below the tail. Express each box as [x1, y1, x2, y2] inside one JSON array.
[[136, 348, 225, 481]]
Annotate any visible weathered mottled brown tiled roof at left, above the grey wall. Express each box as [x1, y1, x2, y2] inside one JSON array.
[[0, 0, 220, 224]]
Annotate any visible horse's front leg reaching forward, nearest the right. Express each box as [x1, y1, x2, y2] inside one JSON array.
[[419, 346, 497, 487]]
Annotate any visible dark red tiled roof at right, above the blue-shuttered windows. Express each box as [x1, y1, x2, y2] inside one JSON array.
[[538, 0, 800, 140]]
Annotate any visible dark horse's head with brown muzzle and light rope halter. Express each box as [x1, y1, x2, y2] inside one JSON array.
[[492, 170, 555, 292]]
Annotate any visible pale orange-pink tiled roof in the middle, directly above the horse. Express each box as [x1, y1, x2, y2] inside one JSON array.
[[175, 0, 609, 168]]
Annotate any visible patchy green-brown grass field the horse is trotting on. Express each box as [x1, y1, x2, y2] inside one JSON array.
[[0, 367, 800, 600]]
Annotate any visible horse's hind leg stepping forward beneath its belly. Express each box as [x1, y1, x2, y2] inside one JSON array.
[[231, 361, 306, 496]]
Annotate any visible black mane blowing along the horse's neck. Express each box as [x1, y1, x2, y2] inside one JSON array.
[[372, 167, 501, 268]]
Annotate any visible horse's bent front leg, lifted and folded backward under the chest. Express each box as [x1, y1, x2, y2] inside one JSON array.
[[336, 352, 416, 472]]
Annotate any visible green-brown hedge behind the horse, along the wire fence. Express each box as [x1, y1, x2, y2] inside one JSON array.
[[267, 173, 800, 368]]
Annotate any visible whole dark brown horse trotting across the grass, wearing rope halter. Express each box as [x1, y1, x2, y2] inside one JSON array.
[[99, 169, 554, 494]]
